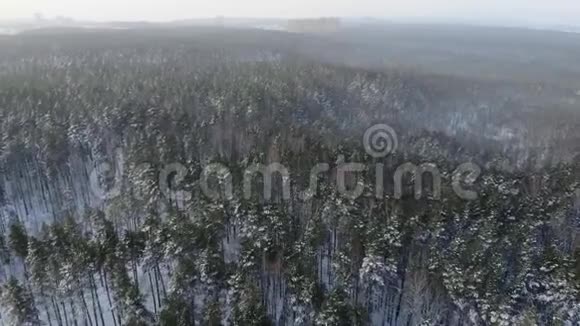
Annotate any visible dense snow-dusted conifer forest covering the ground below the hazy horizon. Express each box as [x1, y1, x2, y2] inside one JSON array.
[[0, 27, 580, 326]]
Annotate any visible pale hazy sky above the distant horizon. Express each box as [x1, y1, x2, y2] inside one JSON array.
[[0, 0, 580, 25]]
